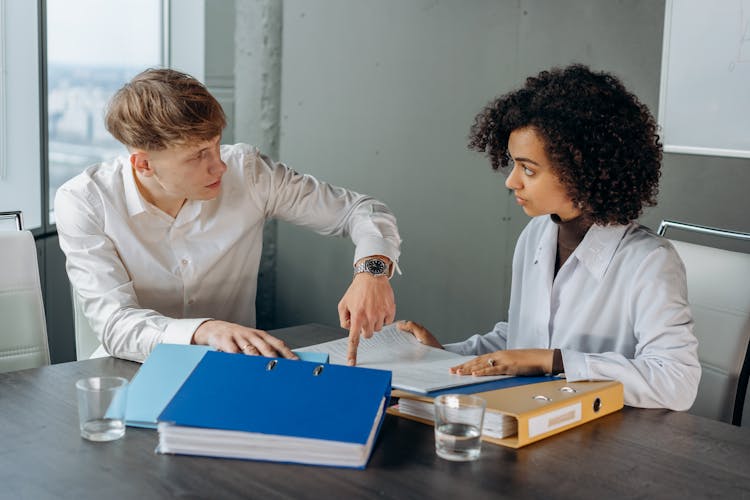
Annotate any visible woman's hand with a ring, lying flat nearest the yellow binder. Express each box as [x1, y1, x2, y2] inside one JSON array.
[[451, 349, 555, 376]]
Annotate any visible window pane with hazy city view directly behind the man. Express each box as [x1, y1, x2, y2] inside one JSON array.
[[47, 0, 164, 223]]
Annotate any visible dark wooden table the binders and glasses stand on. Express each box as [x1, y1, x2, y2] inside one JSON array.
[[0, 325, 750, 500]]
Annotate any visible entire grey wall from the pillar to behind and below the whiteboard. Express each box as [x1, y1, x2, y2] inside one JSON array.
[[276, 0, 750, 341]]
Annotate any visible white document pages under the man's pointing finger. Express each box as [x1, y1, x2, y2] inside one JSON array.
[[296, 324, 508, 394]]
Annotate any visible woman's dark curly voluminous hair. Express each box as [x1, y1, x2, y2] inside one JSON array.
[[469, 64, 662, 225]]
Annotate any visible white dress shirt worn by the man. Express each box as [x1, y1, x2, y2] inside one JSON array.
[[55, 144, 401, 361]]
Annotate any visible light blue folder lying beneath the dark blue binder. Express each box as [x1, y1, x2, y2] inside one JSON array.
[[125, 344, 328, 429]]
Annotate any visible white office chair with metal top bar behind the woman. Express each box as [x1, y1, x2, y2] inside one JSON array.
[[658, 220, 750, 425]]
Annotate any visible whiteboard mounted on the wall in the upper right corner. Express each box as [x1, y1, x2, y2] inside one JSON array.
[[659, 0, 750, 158]]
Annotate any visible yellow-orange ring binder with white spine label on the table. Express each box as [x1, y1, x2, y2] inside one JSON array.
[[388, 379, 623, 448]]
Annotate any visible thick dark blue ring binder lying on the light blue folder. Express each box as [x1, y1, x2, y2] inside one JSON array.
[[157, 352, 391, 468]]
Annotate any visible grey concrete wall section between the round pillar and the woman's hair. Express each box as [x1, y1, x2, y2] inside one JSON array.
[[276, 0, 520, 339]]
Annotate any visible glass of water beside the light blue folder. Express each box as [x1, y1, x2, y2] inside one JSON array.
[[76, 377, 128, 441]]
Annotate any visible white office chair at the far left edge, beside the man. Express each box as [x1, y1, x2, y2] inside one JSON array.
[[0, 212, 50, 372]]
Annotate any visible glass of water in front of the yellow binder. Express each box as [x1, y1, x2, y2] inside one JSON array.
[[433, 394, 487, 462]]
